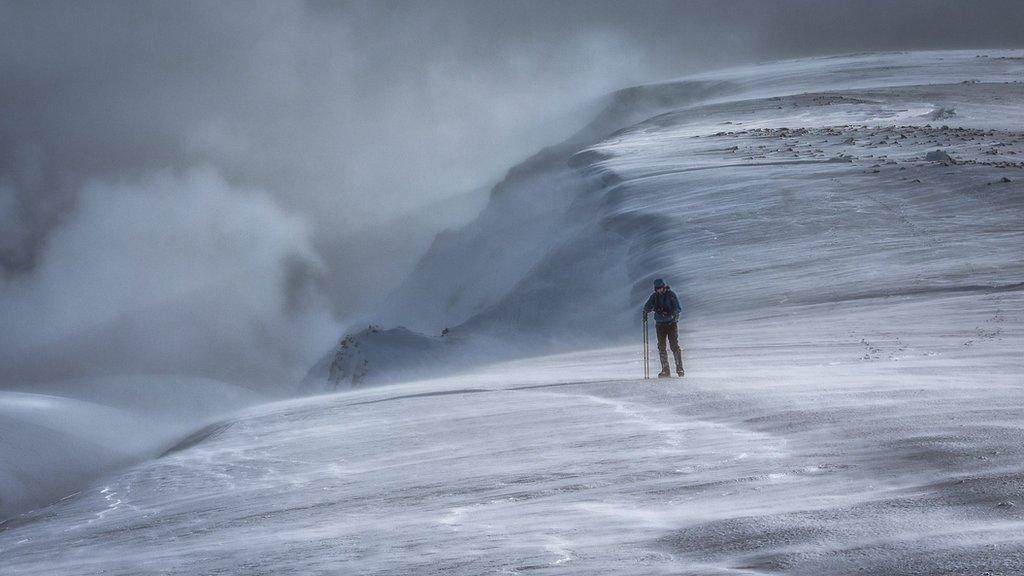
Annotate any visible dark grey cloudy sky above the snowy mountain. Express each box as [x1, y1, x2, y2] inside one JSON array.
[[0, 0, 1024, 381]]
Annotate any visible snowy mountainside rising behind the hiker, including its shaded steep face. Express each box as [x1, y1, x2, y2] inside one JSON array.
[[304, 51, 1024, 389]]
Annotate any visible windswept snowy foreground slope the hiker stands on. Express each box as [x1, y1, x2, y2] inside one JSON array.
[[0, 292, 1024, 575]]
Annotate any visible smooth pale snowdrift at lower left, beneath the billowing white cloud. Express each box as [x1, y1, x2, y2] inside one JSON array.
[[0, 376, 260, 520]]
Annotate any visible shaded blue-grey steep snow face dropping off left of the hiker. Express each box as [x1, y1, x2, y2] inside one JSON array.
[[367, 80, 736, 339]]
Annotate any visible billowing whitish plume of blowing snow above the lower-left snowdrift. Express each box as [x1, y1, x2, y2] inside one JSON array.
[[0, 171, 332, 386]]
